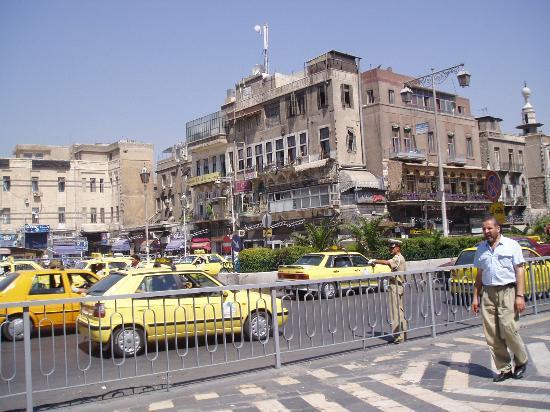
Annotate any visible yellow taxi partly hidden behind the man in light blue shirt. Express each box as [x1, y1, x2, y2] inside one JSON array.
[[449, 246, 550, 298]]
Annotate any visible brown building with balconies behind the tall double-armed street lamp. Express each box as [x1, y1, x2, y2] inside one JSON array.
[[362, 68, 490, 234]]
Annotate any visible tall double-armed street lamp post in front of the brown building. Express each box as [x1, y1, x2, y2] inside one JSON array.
[[401, 63, 470, 237]]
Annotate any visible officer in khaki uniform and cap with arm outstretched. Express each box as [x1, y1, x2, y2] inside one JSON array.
[[369, 239, 408, 344]]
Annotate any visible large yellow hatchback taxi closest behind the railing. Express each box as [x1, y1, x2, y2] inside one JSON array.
[[77, 266, 288, 356]]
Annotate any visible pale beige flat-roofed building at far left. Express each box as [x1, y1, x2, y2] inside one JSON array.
[[0, 141, 153, 254]]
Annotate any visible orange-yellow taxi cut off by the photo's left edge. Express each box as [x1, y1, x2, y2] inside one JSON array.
[[0, 269, 99, 340]]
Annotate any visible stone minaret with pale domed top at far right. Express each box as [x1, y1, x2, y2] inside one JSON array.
[[517, 84, 550, 216]]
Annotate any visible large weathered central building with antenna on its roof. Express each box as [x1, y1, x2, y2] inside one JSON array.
[[187, 51, 384, 251]]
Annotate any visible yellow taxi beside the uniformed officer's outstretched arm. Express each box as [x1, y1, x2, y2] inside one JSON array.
[[277, 248, 390, 299]]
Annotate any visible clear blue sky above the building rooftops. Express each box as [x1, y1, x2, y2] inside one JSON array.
[[0, 0, 550, 156]]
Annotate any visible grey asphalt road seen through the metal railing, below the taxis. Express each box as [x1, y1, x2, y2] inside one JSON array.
[[0, 285, 492, 409]]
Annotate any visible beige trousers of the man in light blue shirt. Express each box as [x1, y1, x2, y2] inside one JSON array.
[[481, 286, 527, 372]]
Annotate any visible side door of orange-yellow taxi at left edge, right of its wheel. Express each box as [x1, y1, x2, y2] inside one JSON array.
[[28, 272, 72, 328]]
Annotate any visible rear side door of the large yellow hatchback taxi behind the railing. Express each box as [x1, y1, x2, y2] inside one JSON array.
[[132, 273, 180, 338]]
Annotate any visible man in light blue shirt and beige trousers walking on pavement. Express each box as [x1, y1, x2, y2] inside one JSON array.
[[472, 216, 528, 382]]
